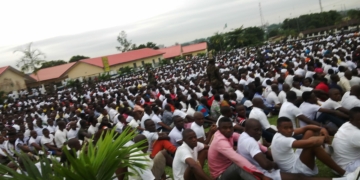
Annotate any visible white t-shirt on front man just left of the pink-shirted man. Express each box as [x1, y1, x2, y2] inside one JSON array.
[[173, 142, 205, 180]]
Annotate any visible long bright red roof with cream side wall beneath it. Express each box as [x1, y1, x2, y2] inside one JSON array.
[[81, 48, 164, 72]]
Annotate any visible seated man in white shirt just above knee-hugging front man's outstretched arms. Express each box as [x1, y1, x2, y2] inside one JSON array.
[[299, 91, 348, 127]]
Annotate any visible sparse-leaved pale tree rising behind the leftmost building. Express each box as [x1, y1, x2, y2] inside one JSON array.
[[14, 43, 46, 80]]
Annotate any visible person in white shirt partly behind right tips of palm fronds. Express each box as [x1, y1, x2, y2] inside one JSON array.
[[128, 134, 155, 180]]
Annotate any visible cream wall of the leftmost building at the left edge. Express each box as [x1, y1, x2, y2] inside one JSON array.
[[0, 70, 26, 92]]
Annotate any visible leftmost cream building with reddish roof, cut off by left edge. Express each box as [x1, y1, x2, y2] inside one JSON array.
[[0, 66, 35, 93]]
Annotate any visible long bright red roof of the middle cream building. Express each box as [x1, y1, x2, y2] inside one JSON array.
[[81, 48, 164, 67]]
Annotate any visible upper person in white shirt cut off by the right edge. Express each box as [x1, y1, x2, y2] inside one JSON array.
[[341, 85, 360, 110]]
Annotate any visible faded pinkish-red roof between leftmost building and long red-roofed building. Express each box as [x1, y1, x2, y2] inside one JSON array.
[[30, 62, 76, 81]]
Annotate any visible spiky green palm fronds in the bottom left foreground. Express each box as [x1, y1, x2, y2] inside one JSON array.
[[0, 129, 146, 180]]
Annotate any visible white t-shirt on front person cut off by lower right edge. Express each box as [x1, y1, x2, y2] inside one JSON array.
[[332, 122, 360, 169]]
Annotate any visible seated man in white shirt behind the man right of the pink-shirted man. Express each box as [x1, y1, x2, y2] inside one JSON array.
[[249, 97, 276, 143]]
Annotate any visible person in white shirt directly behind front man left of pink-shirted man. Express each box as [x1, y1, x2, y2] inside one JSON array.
[[169, 116, 184, 147]]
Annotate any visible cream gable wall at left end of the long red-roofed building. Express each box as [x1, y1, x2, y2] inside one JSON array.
[[64, 62, 104, 79]]
